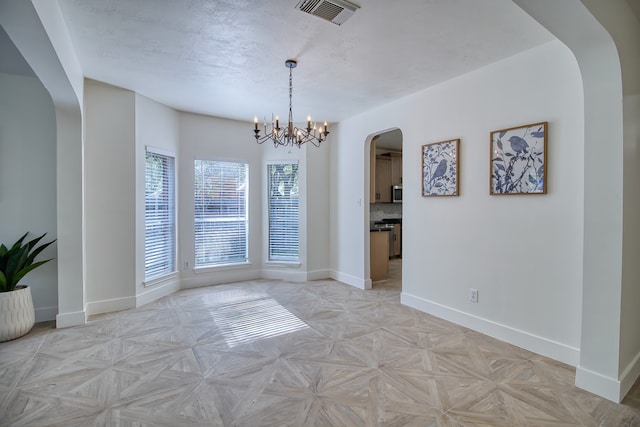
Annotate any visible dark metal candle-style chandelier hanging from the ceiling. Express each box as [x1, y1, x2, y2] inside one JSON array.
[[253, 59, 329, 148]]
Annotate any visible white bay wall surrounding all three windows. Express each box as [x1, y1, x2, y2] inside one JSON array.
[[85, 87, 329, 308]]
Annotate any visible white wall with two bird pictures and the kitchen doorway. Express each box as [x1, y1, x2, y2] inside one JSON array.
[[331, 42, 584, 365]]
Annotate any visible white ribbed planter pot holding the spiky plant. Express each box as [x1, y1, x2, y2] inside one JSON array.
[[0, 286, 36, 342]]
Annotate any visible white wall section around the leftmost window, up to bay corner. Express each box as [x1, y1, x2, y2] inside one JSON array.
[[85, 80, 180, 314]]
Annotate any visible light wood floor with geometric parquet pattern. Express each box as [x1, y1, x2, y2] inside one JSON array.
[[0, 262, 640, 427]]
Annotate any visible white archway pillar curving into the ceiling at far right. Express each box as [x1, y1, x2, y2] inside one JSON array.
[[514, 0, 640, 402]]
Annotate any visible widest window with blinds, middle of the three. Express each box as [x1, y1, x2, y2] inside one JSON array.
[[194, 160, 249, 267]]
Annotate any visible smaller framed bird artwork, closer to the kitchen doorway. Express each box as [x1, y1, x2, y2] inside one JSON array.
[[422, 139, 460, 197]]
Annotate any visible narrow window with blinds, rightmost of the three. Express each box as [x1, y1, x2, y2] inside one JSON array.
[[267, 163, 300, 261]]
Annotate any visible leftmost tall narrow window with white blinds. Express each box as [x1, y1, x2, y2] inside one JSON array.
[[144, 149, 176, 281]]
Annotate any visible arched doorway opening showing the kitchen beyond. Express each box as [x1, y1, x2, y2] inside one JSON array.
[[365, 129, 404, 290]]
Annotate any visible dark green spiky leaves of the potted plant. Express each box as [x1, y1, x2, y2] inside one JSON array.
[[0, 231, 55, 292]]
